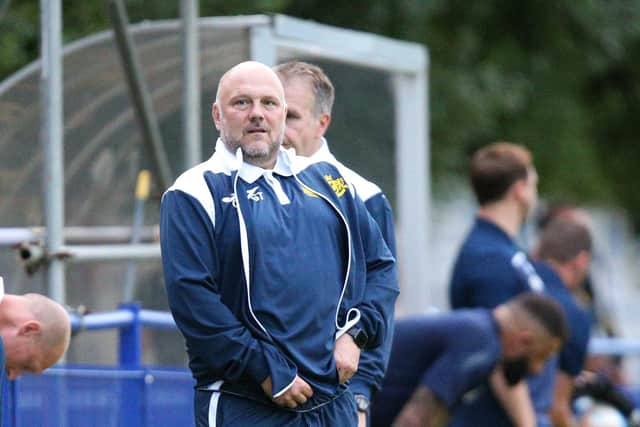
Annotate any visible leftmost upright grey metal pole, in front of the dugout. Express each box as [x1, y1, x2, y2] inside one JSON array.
[[40, 0, 66, 304]]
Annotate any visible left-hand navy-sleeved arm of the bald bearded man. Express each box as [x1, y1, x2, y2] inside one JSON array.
[[160, 190, 297, 398]]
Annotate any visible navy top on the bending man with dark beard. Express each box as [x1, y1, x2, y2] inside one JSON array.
[[371, 309, 501, 427]]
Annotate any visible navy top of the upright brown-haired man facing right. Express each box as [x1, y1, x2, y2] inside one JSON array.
[[449, 218, 544, 309]]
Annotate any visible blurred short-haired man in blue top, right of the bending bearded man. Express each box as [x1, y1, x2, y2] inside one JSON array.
[[456, 217, 592, 427]]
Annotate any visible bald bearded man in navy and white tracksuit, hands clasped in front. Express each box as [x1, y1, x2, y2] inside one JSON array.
[[160, 61, 398, 427]]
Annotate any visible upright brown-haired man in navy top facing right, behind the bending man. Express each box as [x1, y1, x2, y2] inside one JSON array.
[[449, 142, 544, 427]]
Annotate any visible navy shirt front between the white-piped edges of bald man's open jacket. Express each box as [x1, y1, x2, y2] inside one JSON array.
[[245, 174, 349, 394]]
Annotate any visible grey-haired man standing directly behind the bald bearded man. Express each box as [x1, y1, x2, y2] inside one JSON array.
[[274, 61, 396, 427]]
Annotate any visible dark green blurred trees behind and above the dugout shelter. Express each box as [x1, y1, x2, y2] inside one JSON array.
[[0, 0, 640, 225]]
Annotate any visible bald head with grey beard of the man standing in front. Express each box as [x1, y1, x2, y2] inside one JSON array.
[[212, 61, 287, 169]]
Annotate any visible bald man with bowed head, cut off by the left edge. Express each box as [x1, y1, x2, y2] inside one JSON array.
[[0, 277, 71, 424]]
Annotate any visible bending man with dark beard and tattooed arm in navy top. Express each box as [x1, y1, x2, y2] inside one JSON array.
[[371, 292, 567, 427]]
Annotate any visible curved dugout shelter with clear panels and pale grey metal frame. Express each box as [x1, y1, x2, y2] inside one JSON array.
[[0, 11, 430, 324]]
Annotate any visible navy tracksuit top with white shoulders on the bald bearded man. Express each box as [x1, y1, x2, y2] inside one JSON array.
[[160, 141, 398, 424]]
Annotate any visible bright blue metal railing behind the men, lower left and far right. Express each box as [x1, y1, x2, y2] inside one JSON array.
[[3, 304, 640, 427]]
